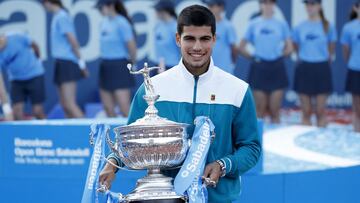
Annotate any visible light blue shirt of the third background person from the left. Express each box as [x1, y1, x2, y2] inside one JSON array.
[[100, 15, 134, 59]]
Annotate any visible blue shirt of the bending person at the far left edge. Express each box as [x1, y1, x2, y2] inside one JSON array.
[[0, 34, 44, 80]]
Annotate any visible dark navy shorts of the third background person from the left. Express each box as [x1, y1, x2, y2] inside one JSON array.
[[99, 59, 135, 92]]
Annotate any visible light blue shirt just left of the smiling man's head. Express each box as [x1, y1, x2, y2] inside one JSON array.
[[155, 19, 181, 67]]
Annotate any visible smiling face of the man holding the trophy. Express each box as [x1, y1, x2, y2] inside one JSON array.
[[176, 26, 216, 69]]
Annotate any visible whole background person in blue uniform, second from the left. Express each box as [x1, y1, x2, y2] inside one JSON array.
[[43, 0, 88, 118]]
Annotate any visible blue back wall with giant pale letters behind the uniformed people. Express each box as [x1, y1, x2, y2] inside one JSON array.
[[0, 0, 352, 111]]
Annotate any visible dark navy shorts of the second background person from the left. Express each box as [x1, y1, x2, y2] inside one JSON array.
[[54, 59, 83, 85]]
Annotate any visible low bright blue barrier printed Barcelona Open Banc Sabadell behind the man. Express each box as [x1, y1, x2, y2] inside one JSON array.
[[0, 119, 360, 203]]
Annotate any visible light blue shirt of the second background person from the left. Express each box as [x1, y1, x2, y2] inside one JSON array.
[[51, 9, 78, 62]]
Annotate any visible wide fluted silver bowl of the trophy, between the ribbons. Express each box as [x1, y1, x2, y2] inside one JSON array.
[[114, 122, 189, 170]]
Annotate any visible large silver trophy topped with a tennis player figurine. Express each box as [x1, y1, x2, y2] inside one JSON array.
[[106, 63, 190, 203]]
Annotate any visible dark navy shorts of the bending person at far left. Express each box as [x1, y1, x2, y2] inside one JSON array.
[[10, 75, 45, 105]]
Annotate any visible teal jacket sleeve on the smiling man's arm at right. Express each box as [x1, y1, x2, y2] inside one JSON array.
[[222, 88, 261, 178]]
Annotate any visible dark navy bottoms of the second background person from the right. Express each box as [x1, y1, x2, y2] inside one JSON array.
[[294, 61, 333, 96]]
